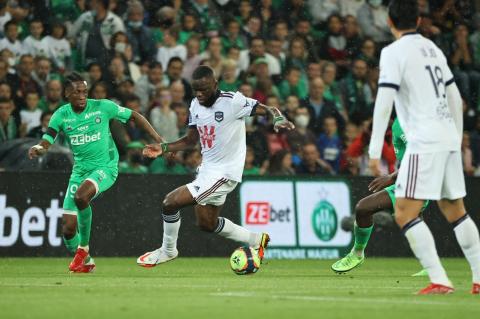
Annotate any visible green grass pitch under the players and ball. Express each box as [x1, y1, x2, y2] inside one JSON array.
[[0, 258, 480, 319]]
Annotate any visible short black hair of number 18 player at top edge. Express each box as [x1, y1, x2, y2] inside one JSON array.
[[388, 0, 419, 30]]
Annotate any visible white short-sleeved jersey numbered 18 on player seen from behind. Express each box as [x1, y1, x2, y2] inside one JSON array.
[[378, 33, 460, 154]]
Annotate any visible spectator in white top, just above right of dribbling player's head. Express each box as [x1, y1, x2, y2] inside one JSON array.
[[238, 38, 281, 76]]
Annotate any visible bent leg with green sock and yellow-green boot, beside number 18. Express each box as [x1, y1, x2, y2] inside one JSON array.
[[332, 188, 393, 273]]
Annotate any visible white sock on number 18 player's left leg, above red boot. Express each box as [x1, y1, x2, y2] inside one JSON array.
[[402, 218, 453, 287]]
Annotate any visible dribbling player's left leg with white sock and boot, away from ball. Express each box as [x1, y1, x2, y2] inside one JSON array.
[[137, 185, 196, 267]]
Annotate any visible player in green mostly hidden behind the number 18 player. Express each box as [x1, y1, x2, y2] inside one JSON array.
[[332, 119, 428, 276]]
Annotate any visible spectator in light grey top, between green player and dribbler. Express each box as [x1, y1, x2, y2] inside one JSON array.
[[150, 88, 178, 142]]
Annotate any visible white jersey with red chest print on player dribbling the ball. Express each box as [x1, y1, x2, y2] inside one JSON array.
[[188, 92, 258, 182]]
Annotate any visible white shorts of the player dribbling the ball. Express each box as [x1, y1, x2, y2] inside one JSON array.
[[187, 173, 238, 206]]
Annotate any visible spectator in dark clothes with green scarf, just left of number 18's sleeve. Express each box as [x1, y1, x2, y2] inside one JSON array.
[[340, 59, 374, 124]]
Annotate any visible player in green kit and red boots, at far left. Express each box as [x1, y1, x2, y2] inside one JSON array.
[[29, 73, 162, 272]]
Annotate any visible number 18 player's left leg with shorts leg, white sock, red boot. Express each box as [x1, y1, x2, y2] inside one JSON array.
[[395, 152, 453, 294]]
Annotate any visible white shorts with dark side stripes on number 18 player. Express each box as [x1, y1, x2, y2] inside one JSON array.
[[395, 151, 466, 200]]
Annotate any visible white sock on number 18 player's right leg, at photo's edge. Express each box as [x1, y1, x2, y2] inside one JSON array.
[[452, 214, 480, 283]]
